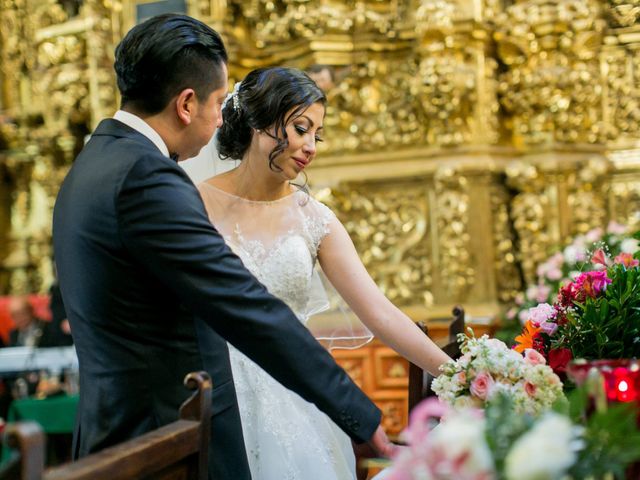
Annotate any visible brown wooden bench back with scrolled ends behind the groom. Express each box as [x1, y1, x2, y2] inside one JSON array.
[[0, 372, 211, 480]]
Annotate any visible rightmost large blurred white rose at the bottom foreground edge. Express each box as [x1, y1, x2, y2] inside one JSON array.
[[505, 412, 581, 480]]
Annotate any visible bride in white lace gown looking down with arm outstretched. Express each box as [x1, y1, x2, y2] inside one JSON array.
[[198, 68, 448, 480]]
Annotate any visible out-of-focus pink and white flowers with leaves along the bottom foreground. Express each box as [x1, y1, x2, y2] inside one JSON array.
[[384, 391, 640, 480]]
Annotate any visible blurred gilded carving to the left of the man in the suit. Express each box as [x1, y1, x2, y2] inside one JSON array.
[[0, 0, 120, 292]]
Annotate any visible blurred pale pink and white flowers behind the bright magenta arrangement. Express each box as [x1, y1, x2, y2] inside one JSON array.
[[496, 222, 638, 343]]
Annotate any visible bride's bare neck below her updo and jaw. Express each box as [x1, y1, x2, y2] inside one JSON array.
[[229, 155, 291, 201]]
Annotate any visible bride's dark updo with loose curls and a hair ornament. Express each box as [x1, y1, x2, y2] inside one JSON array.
[[217, 67, 327, 170]]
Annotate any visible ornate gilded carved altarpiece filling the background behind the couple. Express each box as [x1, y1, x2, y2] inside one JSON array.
[[0, 0, 640, 434]]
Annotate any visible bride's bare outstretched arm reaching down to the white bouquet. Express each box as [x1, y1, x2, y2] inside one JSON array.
[[318, 217, 449, 375]]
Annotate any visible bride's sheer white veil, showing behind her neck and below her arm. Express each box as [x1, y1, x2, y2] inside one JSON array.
[[184, 127, 373, 350]]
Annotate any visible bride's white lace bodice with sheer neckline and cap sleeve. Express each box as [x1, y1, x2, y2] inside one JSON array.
[[199, 183, 333, 316]]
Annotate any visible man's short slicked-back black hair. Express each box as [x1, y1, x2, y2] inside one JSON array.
[[114, 14, 228, 115]]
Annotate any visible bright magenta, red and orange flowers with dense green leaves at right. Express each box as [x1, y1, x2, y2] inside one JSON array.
[[515, 233, 640, 374]]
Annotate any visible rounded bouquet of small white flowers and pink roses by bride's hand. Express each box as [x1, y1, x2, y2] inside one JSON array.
[[431, 334, 562, 414]]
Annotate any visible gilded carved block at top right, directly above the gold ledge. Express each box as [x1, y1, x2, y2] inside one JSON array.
[[494, 0, 605, 145]]
